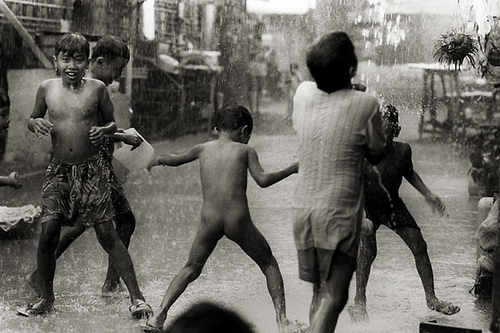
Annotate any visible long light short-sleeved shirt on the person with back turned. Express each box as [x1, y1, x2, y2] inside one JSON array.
[[292, 82, 385, 257]]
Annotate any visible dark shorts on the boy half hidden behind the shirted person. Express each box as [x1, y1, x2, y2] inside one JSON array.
[[366, 204, 420, 230]]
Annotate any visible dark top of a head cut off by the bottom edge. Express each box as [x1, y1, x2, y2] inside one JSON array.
[[165, 302, 255, 333]]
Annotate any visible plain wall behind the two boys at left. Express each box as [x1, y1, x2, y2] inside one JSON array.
[[4, 69, 130, 166]]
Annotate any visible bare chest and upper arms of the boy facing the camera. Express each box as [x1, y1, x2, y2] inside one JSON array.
[[35, 79, 113, 163]]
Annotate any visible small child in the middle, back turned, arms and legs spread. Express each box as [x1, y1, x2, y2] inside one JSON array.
[[143, 105, 298, 332]]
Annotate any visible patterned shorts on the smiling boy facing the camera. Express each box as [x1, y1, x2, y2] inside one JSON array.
[[41, 154, 115, 228]]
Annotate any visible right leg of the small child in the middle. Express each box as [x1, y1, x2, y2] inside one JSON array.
[[226, 220, 300, 332]]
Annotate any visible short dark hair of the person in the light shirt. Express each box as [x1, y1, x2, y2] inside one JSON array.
[[306, 31, 358, 93]]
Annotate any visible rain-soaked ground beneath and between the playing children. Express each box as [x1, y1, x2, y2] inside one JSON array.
[[0, 99, 490, 333]]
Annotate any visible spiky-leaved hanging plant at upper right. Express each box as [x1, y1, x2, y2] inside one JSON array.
[[433, 30, 478, 70]]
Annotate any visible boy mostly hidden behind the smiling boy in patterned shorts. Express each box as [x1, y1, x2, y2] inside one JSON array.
[[26, 35, 142, 293]]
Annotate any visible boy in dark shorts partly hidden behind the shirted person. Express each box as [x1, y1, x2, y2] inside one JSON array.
[[348, 105, 460, 321]]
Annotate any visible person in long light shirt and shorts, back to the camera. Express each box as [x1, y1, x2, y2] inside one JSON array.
[[292, 32, 385, 333]]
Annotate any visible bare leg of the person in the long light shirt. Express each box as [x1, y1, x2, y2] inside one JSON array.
[[307, 254, 356, 333]]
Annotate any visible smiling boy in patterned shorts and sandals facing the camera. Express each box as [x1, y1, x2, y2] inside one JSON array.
[[19, 33, 152, 317]]
